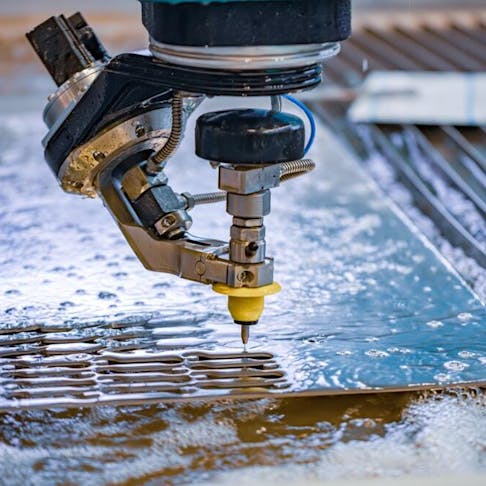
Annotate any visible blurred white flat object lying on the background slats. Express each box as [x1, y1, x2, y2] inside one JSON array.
[[348, 71, 486, 126]]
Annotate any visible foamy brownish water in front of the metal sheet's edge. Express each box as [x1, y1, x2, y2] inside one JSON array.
[[0, 393, 486, 485]]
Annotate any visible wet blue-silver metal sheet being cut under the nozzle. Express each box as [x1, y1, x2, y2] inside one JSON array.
[[0, 98, 486, 409]]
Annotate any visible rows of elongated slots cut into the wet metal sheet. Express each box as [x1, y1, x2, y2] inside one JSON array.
[[0, 321, 288, 409]]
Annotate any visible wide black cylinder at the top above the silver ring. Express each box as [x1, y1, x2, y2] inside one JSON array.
[[142, 0, 351, 47]]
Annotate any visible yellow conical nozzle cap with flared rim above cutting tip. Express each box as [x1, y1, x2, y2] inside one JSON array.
[[213, 282, 282, 323]]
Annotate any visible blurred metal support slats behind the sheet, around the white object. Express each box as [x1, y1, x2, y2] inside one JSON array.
[[316, 9, 486, 270]]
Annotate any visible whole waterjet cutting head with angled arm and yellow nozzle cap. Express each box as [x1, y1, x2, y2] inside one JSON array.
[[27, 0, 350, 344]]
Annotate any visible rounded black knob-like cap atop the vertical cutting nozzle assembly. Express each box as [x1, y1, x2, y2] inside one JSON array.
[[196, 109, 305, 165]]
